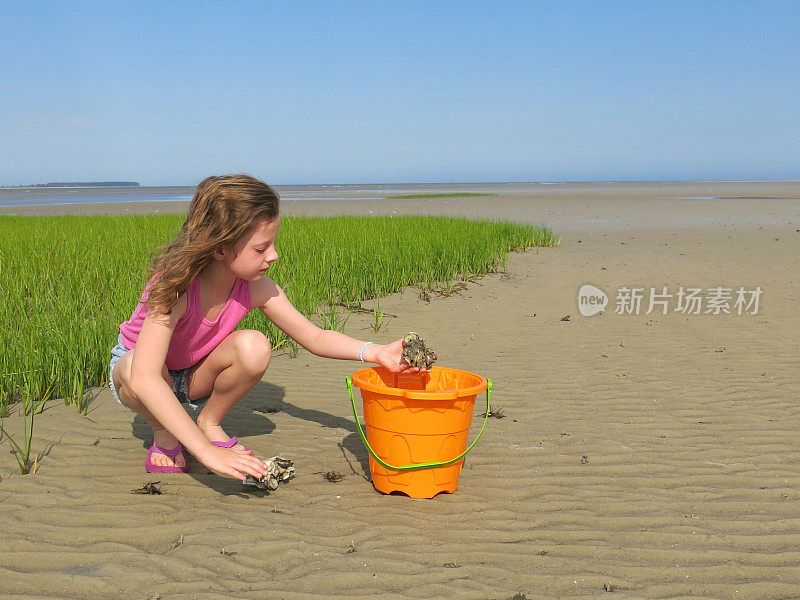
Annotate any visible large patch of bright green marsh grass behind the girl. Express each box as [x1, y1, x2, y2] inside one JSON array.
[[0, 215, 556, 408]]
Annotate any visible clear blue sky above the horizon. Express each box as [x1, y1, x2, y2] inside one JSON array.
[[0, 0, 800, 185]]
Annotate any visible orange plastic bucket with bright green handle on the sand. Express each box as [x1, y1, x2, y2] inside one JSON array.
[[347, 367, 492, 498]]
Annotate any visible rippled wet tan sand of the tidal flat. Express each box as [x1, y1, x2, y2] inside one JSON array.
[[0, 184, 800, 599]]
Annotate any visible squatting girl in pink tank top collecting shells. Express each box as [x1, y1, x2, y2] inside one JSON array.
[[109, 175, 418, 480]]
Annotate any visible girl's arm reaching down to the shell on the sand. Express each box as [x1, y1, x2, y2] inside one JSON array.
[[130, 295, 266, 480]]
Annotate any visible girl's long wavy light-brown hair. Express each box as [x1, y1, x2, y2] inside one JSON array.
[[147, 175, 280, 314]]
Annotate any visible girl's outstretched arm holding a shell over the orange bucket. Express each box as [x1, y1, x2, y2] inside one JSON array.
[[250, 277, 419, 373]]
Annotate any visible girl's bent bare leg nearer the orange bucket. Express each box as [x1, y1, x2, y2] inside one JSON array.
[[189, 329, 271, 451]]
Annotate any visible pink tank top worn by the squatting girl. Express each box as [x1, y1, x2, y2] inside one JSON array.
[[119, 278, 252, 370]]
